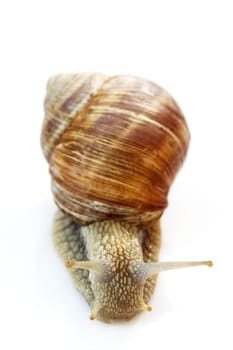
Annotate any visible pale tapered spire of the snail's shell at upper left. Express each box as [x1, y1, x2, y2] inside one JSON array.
[[41, 73, 106, 161]]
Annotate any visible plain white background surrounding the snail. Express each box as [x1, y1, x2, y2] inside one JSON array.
[[0, 0, 233, 350]]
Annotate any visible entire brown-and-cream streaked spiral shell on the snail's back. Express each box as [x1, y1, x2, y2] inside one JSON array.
[[41, 73, 190, 224]]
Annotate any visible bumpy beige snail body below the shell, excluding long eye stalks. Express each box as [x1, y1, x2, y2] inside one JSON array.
[[53, 211, 160, 322]]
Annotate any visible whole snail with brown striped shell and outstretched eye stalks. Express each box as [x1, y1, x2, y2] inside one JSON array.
[[41, 73, 212, 322]]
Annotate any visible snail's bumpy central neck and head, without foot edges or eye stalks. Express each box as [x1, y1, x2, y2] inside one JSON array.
[[81, 221, 150, 319]]
